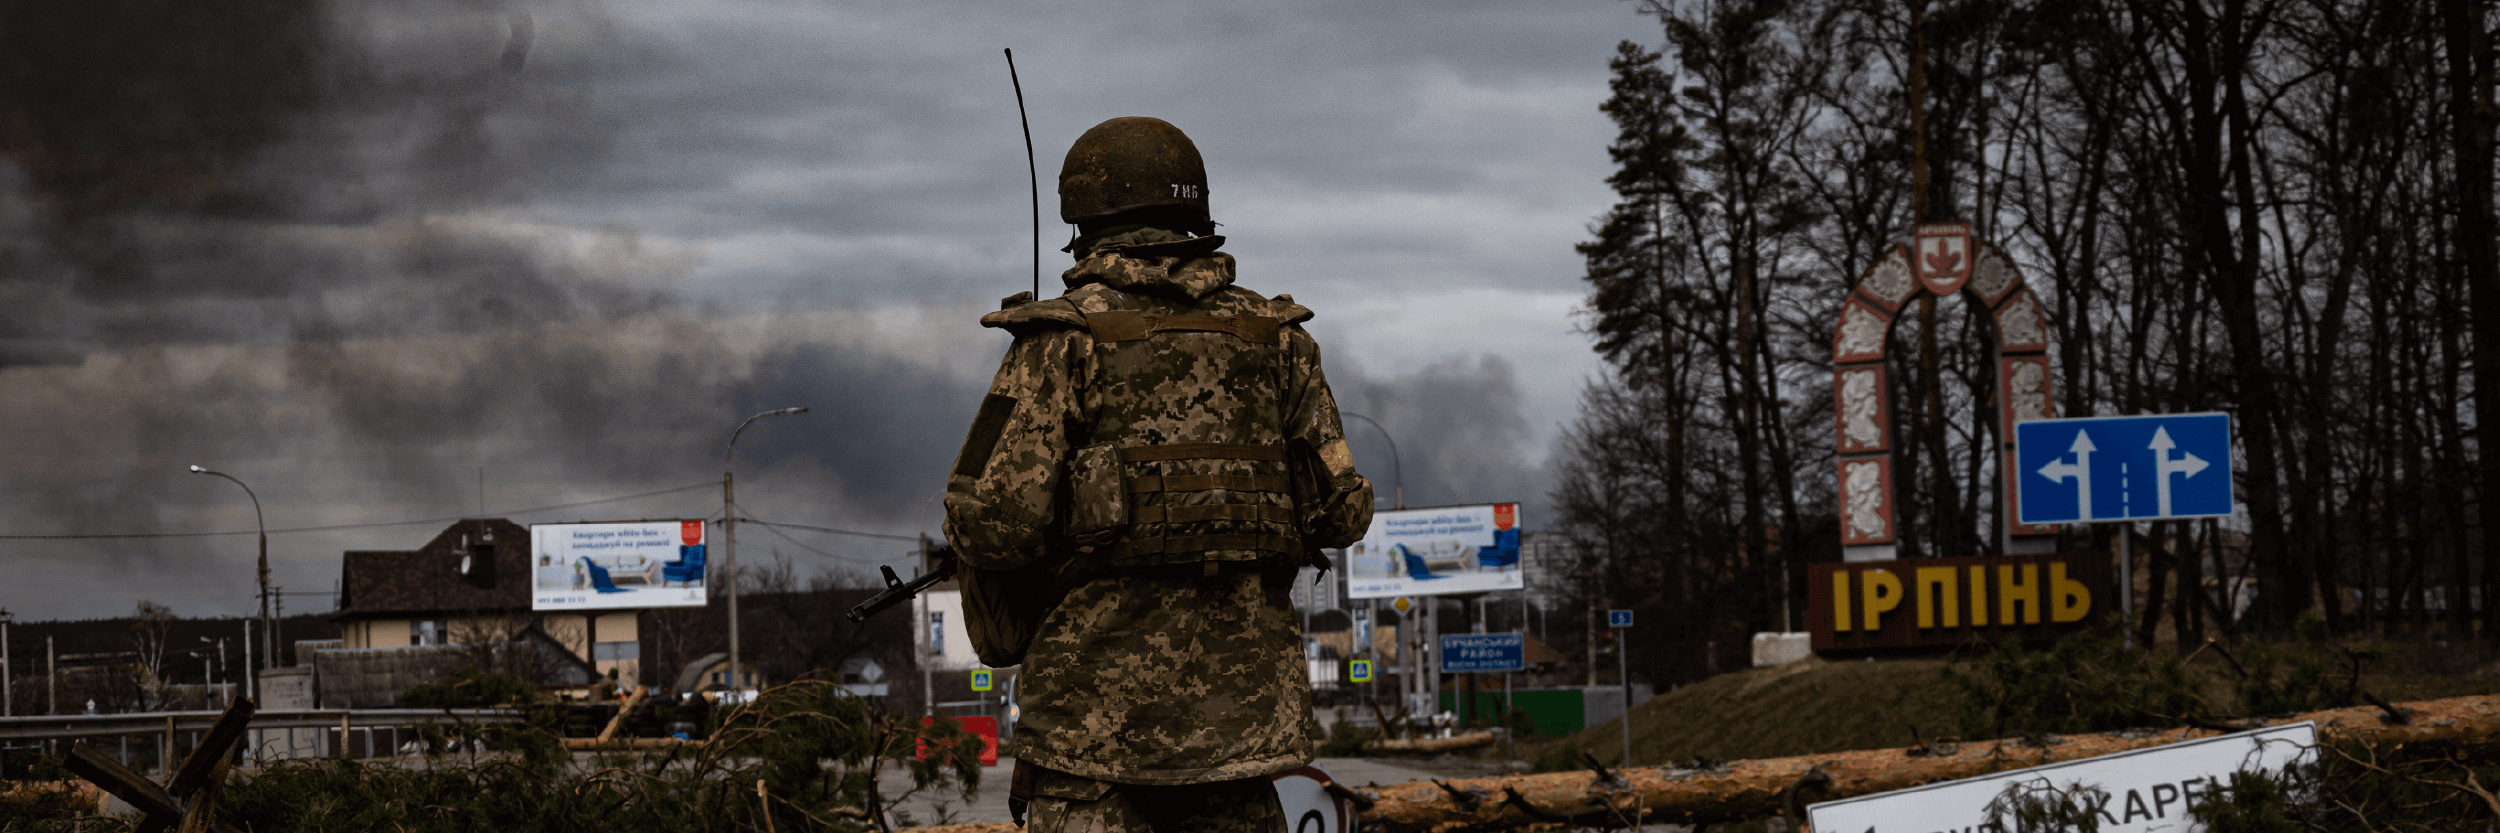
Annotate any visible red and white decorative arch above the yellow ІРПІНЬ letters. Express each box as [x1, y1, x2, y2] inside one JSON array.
[[1833, 223, 2058, 560]]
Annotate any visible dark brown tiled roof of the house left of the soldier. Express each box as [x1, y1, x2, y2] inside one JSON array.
[[338, 518, 530, 618]]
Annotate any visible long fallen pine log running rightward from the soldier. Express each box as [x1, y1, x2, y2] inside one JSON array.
[[1358, 695, 2500, 833]]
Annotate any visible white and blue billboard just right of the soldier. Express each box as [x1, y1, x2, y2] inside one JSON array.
[[1345, 503, 1528, 598]]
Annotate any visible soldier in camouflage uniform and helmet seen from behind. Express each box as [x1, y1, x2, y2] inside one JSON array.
[[945, 118, 1373, 833]]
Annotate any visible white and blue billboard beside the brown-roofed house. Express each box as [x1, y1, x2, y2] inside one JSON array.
[[530, 520, 708, 610]]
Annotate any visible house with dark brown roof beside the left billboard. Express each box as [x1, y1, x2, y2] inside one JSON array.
[[330, 518, 643, 705]]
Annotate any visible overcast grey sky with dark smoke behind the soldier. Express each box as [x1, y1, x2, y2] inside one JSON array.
[[0, 0, 1658, 620]]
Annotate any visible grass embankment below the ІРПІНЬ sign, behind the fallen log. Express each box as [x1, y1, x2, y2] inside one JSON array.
[[1538, 637, 2500, 768]]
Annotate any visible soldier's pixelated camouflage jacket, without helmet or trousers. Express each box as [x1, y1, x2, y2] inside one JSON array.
[[945, 230, 1373, 783]]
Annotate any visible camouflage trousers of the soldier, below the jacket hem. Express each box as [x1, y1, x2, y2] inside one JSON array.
[[1025, 768, 1285, 833]]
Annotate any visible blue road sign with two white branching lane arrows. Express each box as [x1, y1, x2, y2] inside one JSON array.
[[2015, 413, 2230, 523]]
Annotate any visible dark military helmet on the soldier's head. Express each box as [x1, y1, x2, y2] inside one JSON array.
[[1060, 115, 1208, 225]]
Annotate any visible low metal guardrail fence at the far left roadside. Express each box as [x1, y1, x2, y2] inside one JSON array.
[[0, 708, 523, 773]]
